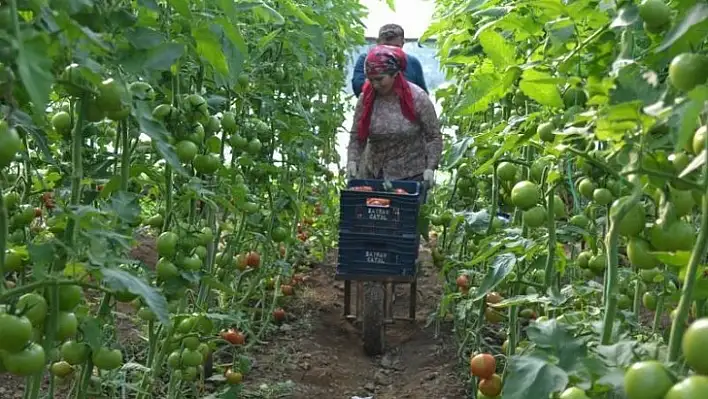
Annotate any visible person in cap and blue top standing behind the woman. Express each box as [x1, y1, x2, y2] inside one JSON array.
[[352, 24, 428, 97]]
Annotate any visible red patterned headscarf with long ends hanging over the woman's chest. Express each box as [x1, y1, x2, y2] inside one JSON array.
[[358, 44, 418, 142]]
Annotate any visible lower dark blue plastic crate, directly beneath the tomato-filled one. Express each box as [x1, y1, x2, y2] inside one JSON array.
[[337, 232, 420, 277]]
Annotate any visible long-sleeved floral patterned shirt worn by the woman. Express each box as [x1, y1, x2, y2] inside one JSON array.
[[348, 82, 442, 180]]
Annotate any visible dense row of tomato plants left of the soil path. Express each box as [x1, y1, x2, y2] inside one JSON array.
[[0, 0, 365, 399]]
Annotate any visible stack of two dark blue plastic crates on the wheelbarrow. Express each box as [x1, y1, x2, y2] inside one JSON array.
[[337, 180, 425, 280]]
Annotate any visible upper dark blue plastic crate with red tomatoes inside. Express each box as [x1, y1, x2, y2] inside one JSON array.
[[339, 180, 425, 236]]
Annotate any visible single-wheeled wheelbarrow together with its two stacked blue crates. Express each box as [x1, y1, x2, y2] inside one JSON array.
[[335, 180, 426, 356]]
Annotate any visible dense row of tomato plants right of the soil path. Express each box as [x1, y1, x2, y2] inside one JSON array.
[[421, 0, 708, 399]]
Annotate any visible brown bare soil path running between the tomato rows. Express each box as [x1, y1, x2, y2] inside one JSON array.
[[247, 249, 466, 399]]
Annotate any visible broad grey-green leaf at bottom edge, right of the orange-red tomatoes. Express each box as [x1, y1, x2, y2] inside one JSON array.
[[504, 356, 568, 399]]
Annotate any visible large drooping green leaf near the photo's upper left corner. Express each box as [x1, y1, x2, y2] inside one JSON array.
[[17, 33, 54, 115]]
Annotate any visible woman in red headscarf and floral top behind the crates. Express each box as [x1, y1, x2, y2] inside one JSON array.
[[347, 45, 442, 187]]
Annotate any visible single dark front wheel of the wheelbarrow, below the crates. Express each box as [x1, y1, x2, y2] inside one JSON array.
[[362, 281, 385, 356]]
